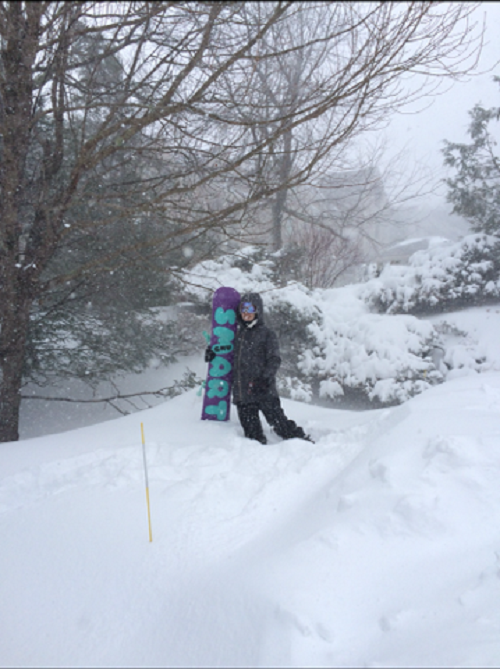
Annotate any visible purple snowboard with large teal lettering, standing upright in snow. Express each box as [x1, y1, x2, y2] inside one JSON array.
[[201, 287, 240, 420]]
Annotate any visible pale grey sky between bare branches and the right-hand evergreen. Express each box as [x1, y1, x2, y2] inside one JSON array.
[[378, 2, 500, 204]]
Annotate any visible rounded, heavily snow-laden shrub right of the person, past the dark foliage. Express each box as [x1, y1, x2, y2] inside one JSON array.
[[299, 289, 444, 405]]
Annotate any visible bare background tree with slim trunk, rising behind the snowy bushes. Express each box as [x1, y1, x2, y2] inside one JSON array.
[[228, 2, 484, 251]]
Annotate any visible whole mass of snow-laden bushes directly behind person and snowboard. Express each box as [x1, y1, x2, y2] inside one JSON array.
[[179, 249, 444, 406]]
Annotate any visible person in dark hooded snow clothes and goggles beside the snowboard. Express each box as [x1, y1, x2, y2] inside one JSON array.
[[205, 293, 312, 444]]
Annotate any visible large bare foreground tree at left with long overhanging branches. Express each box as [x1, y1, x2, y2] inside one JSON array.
[[0, 1, 484, 441]]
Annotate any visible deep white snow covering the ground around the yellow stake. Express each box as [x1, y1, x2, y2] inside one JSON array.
[[0, 308, 500, 667]]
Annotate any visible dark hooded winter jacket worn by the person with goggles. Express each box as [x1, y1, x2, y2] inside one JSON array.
[[233, 293, 281, 404]]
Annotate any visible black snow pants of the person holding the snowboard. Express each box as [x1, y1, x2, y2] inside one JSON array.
[[236, 395, 306, 444]]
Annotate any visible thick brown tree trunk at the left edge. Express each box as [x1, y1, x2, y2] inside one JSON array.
[[0, 2, 43, 442]]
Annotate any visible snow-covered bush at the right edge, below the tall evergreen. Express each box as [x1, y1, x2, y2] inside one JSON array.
[[360, 234, 500, 314]]
